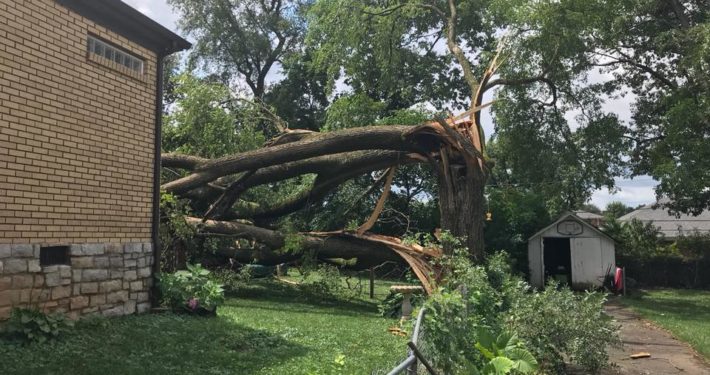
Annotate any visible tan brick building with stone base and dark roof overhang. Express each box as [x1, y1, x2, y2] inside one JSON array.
[[0, 0, 190, 319]]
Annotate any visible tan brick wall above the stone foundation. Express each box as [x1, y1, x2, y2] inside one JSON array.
[[0, 0, 156, 244]]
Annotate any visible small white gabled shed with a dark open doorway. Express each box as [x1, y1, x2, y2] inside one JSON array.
[[528, 213, 616, 289]]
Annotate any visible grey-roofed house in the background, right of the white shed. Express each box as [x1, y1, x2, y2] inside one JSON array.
[[618, 200, 710, 241]]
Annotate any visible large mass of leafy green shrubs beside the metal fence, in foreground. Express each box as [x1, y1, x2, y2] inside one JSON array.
[[425, 234, 619, 374]]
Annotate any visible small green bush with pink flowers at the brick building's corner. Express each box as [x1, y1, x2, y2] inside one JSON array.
[[160, 264, 224, 313]]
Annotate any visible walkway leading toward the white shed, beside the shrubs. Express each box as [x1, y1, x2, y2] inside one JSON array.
[[603, 301, 710, 375]]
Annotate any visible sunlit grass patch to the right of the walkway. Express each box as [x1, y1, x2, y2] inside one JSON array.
[[622, 289, 710, 360]]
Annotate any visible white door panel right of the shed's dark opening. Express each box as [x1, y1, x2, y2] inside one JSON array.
[[571, 237, 604, 286]]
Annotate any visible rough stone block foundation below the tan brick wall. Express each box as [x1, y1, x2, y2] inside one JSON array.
[[0, 243, 153, 319]]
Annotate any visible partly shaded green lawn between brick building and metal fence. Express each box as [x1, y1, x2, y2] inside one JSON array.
[[0, 280, 406, 375]]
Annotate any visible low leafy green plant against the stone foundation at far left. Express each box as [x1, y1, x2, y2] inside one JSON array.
[[2, 308, 74, 343]]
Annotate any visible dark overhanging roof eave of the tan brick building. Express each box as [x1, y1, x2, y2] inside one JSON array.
[[56, 0, 192, 55]]
